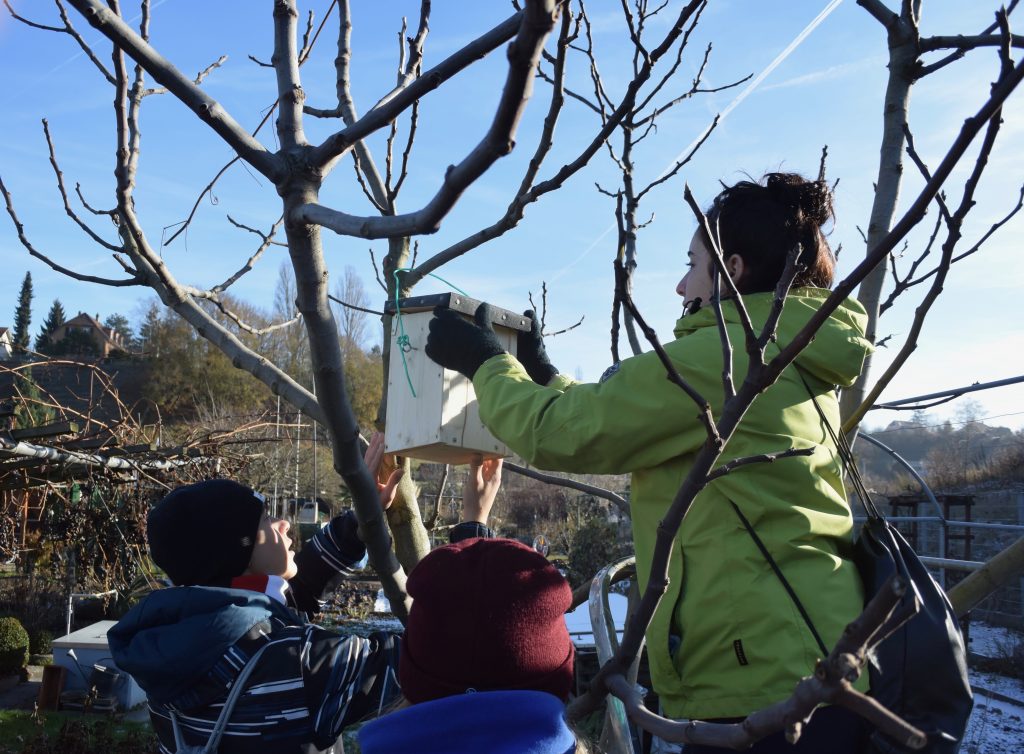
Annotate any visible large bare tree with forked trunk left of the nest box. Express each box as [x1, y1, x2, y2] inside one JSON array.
[[0, 0, 557, 617]]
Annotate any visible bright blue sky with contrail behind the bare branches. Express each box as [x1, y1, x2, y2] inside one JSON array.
[[0, 0, 1024, 427]]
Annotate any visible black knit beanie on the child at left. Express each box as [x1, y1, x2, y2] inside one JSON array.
[[146, 479, 263, 586]]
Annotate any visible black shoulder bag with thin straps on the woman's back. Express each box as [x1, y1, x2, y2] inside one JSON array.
[[733, 377, 974, 754]]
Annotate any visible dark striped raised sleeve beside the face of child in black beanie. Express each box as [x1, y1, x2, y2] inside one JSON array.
[[289, 510, 367, 615]]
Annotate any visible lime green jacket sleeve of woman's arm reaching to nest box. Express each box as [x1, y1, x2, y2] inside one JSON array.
[[473, 350, 722, 473]]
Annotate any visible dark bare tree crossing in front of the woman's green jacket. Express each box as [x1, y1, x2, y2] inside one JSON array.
[[570, 13, 1024, 749]]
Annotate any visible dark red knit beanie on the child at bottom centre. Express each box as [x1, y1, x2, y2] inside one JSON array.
[[398, 539, 575, 704]]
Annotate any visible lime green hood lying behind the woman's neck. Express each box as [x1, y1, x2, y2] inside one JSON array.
[[674, 288, 874, 387]]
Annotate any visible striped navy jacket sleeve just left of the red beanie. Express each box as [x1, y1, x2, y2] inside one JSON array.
[[302, 626, 401, 749]]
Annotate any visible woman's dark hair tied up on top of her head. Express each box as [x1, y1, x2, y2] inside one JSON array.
[[707, 173, 836, 293]]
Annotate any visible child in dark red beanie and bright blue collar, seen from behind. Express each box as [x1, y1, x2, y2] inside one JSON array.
[[358, 452, 583, 754]]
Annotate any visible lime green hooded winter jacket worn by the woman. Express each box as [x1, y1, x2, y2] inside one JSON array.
[[473, 288, 871, 719]]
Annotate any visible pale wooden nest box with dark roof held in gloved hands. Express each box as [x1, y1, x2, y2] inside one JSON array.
[[384, 293, 530, 464]]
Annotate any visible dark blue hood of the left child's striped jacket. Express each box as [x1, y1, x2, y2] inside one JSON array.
[[106, 586, 295, 704]]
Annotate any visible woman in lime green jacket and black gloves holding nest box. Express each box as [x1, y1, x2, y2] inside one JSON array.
[[426, 173, 871, 752]]
